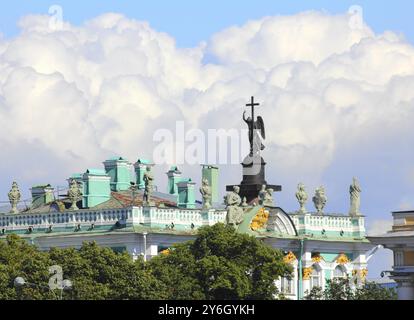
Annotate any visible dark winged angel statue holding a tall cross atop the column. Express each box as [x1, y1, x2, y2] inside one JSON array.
[[243, 97, 266, 156]]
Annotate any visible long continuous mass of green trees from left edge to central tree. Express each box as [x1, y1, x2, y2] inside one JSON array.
[[0, 224, 292, 300]]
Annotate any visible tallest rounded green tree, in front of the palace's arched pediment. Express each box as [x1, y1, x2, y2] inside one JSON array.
[[149, 223, 292, 299]]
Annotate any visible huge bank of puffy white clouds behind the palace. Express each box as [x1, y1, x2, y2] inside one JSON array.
[[0, 12, 414, 225]]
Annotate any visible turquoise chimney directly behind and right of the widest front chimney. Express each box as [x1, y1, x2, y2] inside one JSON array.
[[103, 157, 131, 191]]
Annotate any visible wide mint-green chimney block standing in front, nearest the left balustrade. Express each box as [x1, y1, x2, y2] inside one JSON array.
[[82, 169, 111, 208]]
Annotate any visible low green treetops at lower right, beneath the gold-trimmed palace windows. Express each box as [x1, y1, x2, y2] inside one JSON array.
[[305, 278, 397, 300]]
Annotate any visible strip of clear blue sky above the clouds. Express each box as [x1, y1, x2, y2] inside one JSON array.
[[0, 0, 414, 47]]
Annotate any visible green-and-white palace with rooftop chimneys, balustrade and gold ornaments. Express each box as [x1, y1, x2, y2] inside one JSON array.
[[0, 157, 373, 299]]
